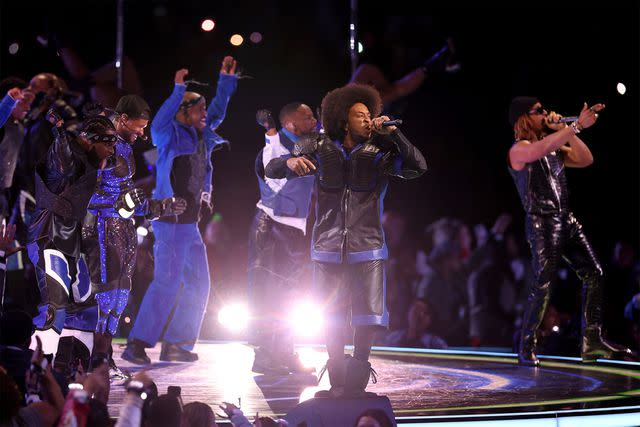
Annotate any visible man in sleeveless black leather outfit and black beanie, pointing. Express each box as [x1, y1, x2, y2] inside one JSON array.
[[508, 96, 632, 366]]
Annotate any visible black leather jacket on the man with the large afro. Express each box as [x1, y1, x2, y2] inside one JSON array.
[[265, 129, 427, 263]]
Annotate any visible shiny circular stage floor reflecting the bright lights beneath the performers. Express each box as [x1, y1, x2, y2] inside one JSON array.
[[109, 343, 640, 425]]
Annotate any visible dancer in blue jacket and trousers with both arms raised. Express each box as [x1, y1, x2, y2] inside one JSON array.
[[122, 56, 238, 364]]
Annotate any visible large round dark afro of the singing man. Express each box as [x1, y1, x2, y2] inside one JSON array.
[[322, 83, 382, 141]]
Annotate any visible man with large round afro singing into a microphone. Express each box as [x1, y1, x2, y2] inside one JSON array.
[[266, 84, 427, 397]]
